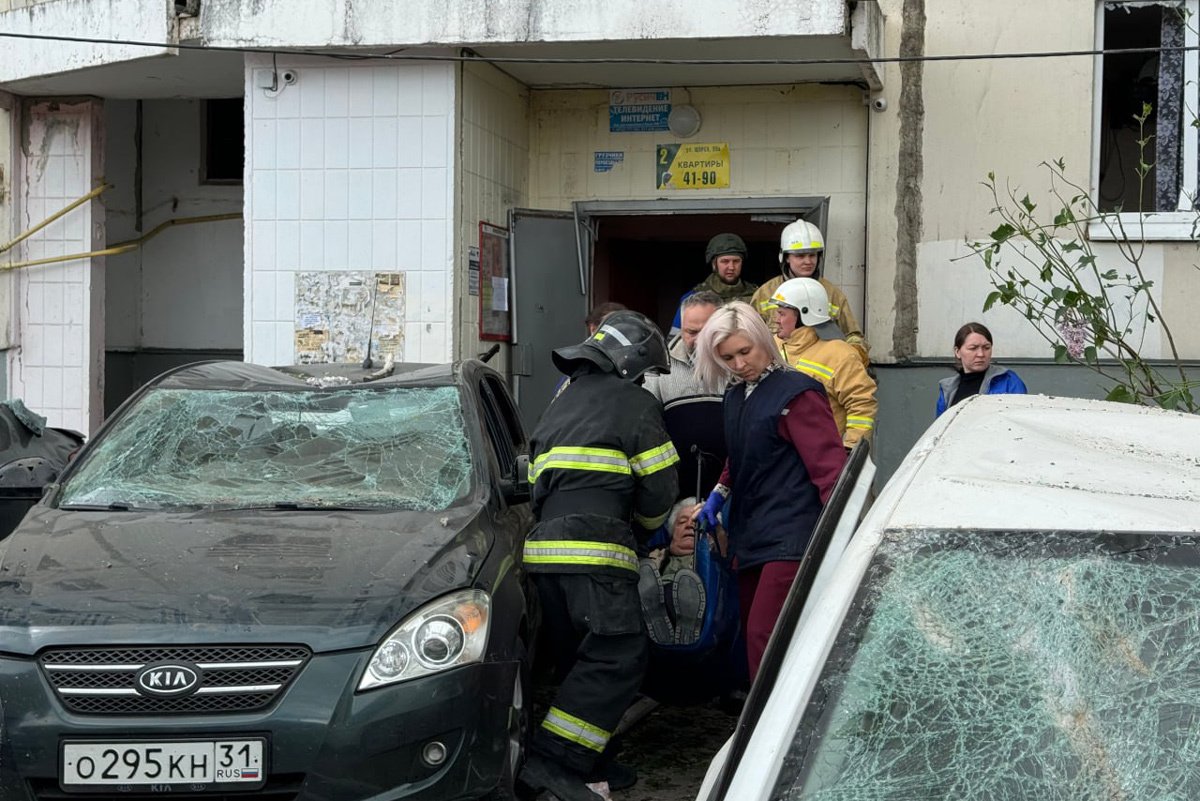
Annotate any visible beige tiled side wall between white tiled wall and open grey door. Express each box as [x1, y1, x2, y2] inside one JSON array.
[[455, 64, 529, 371]]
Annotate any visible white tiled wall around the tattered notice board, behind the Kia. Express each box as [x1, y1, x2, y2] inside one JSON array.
[[245, 56, 455, 365]]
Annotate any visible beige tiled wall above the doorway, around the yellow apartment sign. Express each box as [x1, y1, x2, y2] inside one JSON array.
[[529, 84, 870, 333]]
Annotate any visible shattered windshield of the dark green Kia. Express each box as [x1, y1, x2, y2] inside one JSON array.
[[59, 386, 472, 511]]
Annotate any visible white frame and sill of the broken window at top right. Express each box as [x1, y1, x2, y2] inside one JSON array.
[[1087, 0, 1200, 242]]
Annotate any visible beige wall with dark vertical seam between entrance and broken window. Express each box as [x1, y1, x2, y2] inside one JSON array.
[[866, 0, 1096, 361]]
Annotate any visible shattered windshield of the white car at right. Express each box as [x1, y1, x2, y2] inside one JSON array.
[[772, 531, 1200, 801]]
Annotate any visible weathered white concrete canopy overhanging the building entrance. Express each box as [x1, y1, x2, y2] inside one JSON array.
[[200, 0, 883, 89]]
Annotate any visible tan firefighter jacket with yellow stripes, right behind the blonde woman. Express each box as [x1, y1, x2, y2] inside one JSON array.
[[775, 326, 878, 447]]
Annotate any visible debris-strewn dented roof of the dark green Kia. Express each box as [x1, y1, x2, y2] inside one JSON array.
[[152, 361, 460, 390]]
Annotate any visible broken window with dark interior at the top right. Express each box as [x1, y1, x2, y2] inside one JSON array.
[[1097, 0, 1200, 212]]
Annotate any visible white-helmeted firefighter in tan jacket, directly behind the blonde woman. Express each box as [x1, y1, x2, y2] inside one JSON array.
[[770, 278, 878, 447]]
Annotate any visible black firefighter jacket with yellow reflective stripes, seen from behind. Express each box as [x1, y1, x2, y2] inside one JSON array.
[[524, 369, 679, 582]]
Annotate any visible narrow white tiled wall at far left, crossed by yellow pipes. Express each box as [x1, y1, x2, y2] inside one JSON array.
[[8, 102, 104, 433]]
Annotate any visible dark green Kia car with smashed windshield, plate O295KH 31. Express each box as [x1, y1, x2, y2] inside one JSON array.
[[0, 361, 538, 801]]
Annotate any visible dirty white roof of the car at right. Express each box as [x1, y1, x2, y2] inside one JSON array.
[[886, 395, 1200, 531]]
